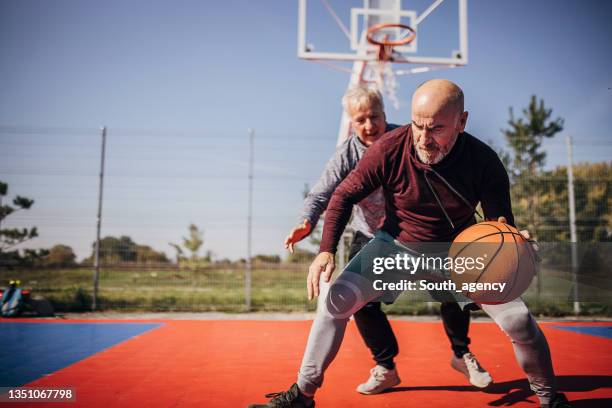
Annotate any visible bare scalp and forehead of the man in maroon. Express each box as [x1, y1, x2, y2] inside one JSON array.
[[412, 79, 463, 114]]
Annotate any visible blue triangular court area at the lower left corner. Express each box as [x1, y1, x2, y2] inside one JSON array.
[[0, 323, 162, 387]]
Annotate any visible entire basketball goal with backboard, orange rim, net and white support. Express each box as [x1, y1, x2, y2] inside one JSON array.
[[297, 0, 468, 144]]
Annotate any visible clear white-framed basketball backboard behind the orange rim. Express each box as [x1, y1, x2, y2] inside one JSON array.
[[297, 0, 468, 67]]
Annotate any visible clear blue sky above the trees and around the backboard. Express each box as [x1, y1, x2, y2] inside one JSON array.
[[0, 0, 612, 258]]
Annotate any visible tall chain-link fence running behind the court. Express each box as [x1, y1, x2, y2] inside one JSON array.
[[0, 127, 612, 314]]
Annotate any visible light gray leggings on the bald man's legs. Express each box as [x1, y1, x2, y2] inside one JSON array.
[[297, 231, 556, 404]]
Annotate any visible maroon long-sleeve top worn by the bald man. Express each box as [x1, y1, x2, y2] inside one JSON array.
[[320, 125, 514, 252]]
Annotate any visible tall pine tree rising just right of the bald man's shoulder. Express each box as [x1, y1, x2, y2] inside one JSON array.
[[502, 95, 563, 239]]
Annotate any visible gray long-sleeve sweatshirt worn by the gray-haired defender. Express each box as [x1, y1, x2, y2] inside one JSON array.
[[300, 124, 398, 237]]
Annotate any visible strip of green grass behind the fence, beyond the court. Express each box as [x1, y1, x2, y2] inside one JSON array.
[[0, 265, 612, 316]]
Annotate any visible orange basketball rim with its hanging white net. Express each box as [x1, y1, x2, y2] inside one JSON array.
[[366, 23, 416, 109]]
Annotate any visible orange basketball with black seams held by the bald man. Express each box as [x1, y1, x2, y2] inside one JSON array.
[[448, 221, 536, 303]]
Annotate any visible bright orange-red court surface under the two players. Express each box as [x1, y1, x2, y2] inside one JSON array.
[[0, 319, 612, 408]]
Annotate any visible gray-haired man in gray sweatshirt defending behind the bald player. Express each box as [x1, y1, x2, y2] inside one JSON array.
[[285, 86, 492, 394]]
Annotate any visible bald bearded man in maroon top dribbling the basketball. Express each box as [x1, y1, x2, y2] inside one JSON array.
[[251, 79, 570, 408]]
